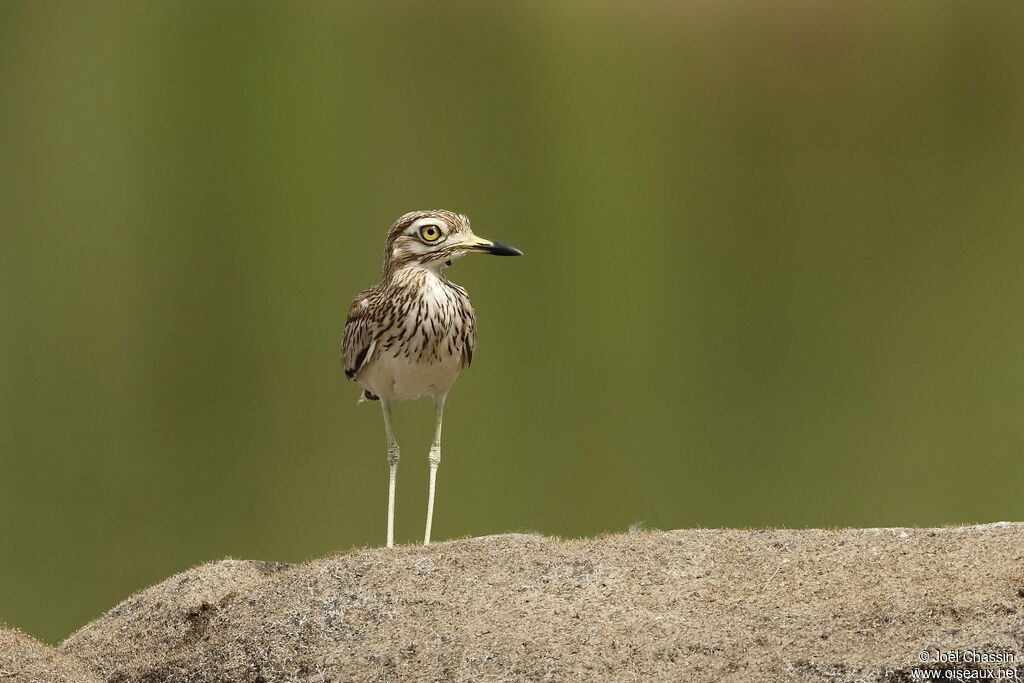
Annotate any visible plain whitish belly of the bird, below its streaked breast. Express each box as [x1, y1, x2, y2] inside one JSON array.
[[355, 349, 462, 400]]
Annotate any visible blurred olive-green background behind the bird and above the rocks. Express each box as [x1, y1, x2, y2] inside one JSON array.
[[0, 0, 1024, 641]]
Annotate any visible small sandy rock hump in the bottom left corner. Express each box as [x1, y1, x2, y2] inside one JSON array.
[[0, 627, 102, 683]]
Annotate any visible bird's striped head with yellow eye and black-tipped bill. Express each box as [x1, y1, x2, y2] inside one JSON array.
[[384, 209, 522, 272]]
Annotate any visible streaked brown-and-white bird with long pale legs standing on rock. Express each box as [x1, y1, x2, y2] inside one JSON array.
[[341, 209, 522, 548]]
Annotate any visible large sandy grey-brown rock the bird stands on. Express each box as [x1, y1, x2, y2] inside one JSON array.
[[62, 523, 1024, 683]]
